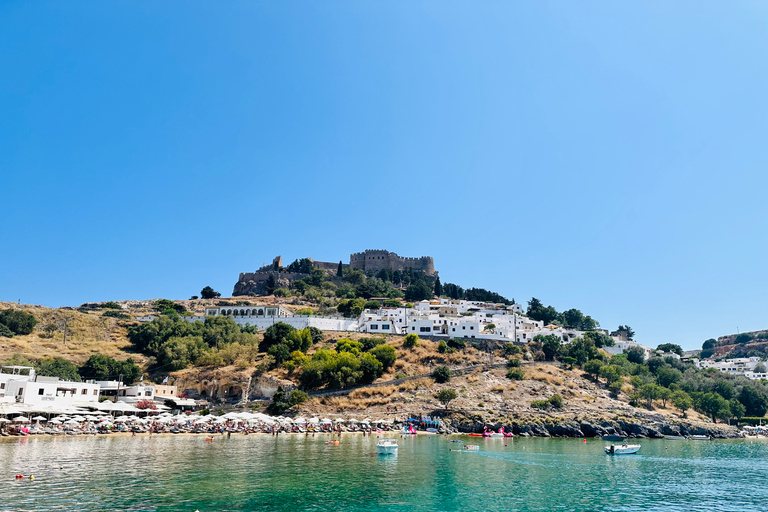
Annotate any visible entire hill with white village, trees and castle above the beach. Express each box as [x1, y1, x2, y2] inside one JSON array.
[[0, 251, 768, 435]]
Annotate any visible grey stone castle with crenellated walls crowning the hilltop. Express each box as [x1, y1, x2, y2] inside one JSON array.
[[232, 249, 437, 296]]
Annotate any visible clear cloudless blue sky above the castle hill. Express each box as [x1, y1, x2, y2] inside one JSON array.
[[0, 0, 768, 348]]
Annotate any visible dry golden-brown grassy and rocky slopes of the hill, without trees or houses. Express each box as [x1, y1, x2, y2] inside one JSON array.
[[0, 298, 752, 436]]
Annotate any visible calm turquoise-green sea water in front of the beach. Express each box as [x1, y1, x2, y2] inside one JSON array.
[[0, 434, 768, 512]]
